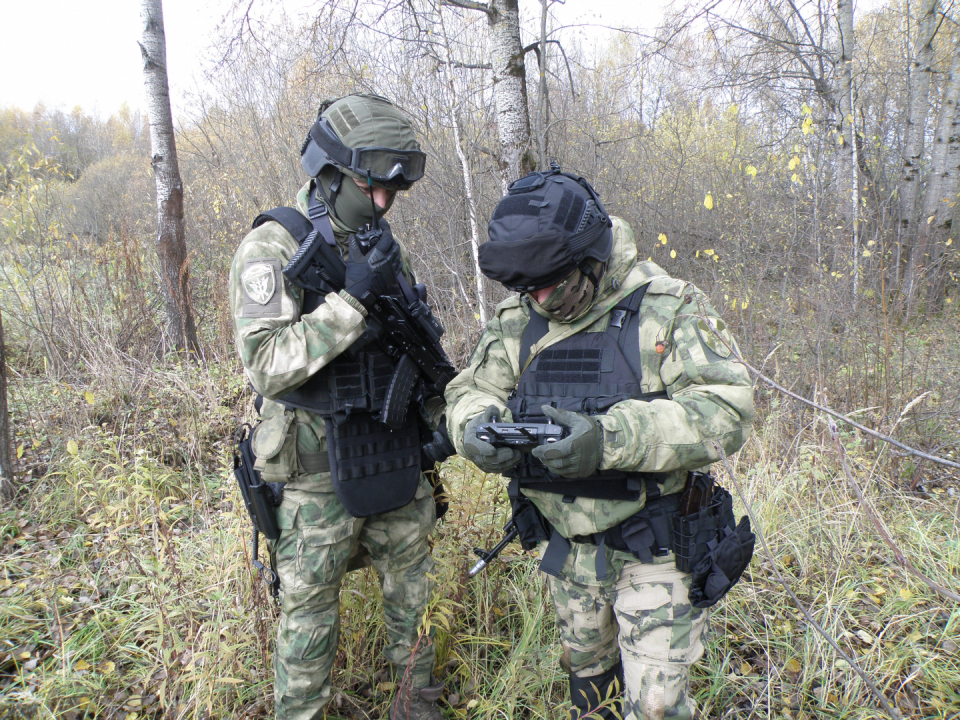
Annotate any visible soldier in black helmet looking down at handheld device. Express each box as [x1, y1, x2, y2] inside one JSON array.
[[446, 167, 753, 720]]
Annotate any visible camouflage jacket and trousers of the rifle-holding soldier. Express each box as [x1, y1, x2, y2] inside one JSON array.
[[229, 181, 444, 720]]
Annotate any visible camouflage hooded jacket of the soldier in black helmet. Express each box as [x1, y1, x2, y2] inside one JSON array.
[[446, 218, 753, 537]]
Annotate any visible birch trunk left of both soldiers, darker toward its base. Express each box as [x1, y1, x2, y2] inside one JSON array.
[[140, 0, 199, 352]]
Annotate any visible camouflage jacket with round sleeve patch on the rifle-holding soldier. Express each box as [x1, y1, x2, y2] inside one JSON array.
[[229, 184, 443, 489]]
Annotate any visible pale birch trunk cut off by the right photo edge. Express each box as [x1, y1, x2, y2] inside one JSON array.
[[916, 39, 960, 315]]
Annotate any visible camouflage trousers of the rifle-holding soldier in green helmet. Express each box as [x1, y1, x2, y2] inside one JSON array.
[[273, 477, 436, 720]]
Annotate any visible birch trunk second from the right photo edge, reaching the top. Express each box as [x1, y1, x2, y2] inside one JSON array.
[[899, 0, 937, 316]]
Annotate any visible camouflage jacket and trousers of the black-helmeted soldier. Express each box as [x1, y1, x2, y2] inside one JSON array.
[[446, 218, 754, 720]]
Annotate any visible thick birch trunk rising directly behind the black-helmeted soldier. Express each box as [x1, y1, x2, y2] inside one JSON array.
[[487, 0, 533, 194]]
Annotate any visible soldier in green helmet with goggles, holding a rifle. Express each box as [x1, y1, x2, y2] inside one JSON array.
[[230, 94, 452, 720]]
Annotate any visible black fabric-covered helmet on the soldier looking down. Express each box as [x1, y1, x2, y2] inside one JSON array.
[[478, 164, 613, 292]]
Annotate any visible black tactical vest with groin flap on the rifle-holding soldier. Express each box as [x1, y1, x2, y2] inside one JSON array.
[[253, 197, 423, 517]]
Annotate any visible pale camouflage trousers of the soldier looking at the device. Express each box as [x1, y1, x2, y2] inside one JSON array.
[[547, 544, 708, 720]]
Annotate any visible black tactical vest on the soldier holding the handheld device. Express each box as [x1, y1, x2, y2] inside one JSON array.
[[507, 285, 667, 500]]
